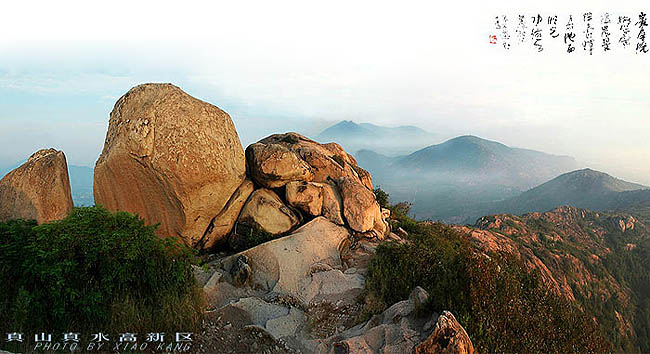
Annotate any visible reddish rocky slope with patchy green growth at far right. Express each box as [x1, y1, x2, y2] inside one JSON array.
[[456, 207, 650, 351]]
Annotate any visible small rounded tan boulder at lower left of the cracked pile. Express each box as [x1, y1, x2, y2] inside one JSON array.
[[238, 188, 300, 235]]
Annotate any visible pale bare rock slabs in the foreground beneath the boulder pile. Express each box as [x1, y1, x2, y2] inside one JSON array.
[[197, 234, 473, 354]]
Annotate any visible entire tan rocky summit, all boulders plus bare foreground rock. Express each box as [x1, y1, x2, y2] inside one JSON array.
[[0, 84, 473, 353]]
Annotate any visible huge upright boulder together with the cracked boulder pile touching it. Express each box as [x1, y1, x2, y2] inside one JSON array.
[[94, 84, 388, 249]]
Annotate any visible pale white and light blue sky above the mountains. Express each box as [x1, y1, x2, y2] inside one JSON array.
[[0, 1, 650, 185]]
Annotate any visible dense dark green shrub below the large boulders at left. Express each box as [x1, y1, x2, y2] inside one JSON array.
[[0, 206, 203, 333]]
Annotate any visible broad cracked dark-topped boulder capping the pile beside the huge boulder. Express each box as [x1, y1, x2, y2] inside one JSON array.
[[246, 133, 372, 190]]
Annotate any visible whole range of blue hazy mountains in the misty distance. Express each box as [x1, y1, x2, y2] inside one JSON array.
[[321, 121, 650, 224]]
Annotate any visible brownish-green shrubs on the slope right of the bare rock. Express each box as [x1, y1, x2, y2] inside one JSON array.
[[366, 212, 611, 353]]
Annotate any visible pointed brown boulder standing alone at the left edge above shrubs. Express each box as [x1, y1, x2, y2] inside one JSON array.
[[0, 149, 73, 224]]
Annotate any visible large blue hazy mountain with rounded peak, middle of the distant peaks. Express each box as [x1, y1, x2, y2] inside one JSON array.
[[355, 131, 579, 223]]
